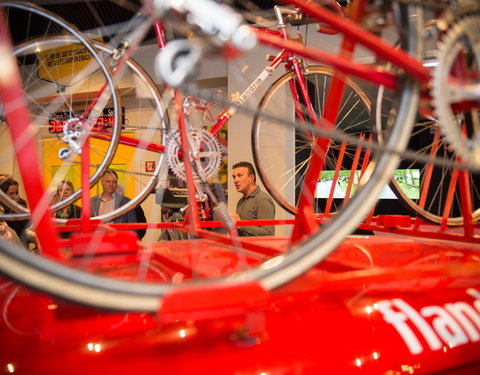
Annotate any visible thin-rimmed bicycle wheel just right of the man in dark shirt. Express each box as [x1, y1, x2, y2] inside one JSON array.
[[251, 66, 371, 214]]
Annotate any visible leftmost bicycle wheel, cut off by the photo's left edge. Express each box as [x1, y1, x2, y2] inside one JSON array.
[[0, 2, 122, 219]]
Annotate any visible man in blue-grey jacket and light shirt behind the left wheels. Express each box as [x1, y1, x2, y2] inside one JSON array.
[[90, 169, 143, 239]]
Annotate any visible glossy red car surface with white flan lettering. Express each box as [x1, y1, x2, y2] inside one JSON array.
[[0, 235, 480, 375]]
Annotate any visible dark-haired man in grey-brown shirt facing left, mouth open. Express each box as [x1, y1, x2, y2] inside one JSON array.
[[232, 161, 275, 236]]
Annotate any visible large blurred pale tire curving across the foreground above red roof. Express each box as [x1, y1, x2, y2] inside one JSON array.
[[0, 0, 421, 313]]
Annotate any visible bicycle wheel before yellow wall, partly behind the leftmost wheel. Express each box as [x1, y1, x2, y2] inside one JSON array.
[[0, 3, 168, 226]]
